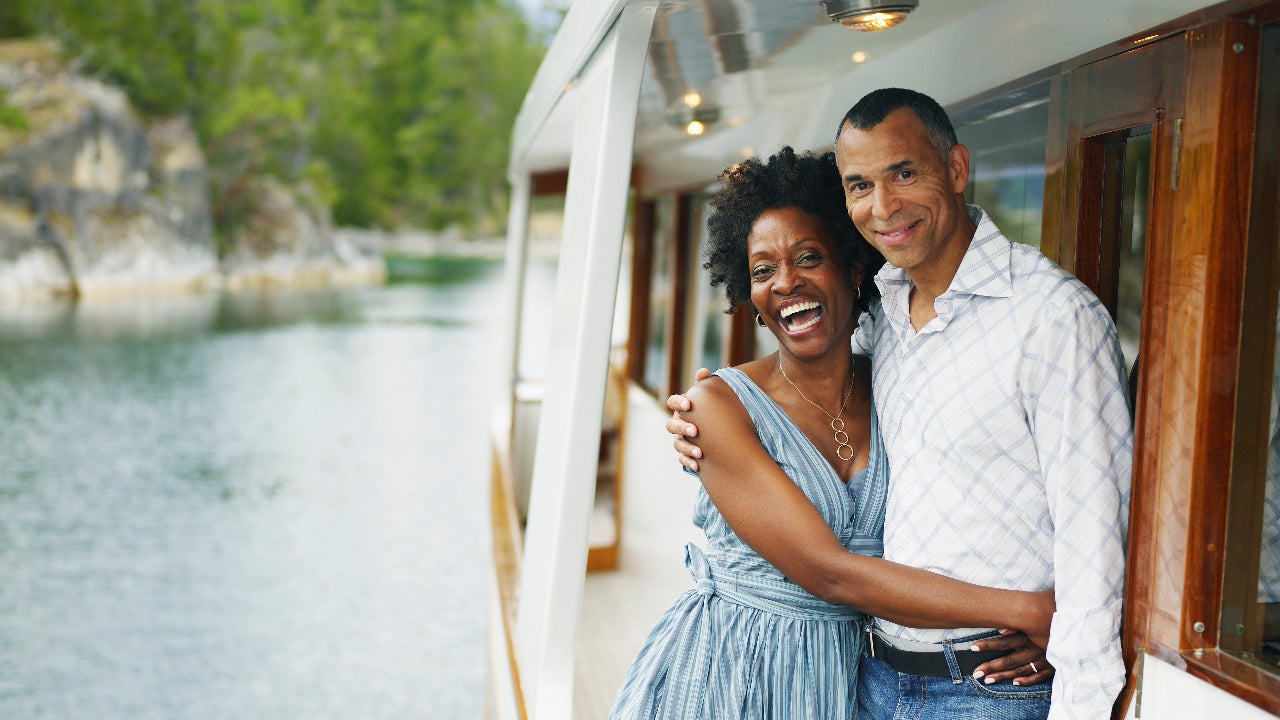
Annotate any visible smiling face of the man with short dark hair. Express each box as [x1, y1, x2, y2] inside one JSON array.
[[836, 108, 972, 281]]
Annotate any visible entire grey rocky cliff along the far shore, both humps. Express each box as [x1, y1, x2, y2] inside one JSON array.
[[0, 41, 384, 299]]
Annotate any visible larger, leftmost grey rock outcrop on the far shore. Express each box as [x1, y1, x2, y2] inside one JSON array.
[[0, 42, 218, 297]]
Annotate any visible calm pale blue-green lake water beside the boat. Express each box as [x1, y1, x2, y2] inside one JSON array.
[[0, 254, 502, 720]]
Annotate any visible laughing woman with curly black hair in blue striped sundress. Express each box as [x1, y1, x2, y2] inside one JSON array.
[[611, 147, 1053, 719]]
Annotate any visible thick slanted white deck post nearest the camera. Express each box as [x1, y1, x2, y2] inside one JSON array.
[[516, 0, 658, 720]]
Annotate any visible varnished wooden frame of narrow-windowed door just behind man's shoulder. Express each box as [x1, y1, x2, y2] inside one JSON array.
[[1043, 33, 1188, 708]]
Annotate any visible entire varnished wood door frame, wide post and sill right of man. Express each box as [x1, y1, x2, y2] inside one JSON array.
[[1043, 3, 1280, 712]]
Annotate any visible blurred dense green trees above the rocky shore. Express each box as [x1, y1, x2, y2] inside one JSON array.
[[0, 0, 543, 229]]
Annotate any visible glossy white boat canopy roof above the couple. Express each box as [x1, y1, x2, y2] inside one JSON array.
[[511, 0, 1210, 193]]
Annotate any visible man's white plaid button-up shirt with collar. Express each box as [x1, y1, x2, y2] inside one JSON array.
[[854, 206, 1133, 720]]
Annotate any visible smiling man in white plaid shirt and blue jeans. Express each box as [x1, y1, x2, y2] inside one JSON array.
[[667, 88, 1133, 720]]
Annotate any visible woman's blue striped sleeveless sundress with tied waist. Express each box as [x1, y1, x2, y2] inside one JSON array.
[[609, 368, 888, 720]]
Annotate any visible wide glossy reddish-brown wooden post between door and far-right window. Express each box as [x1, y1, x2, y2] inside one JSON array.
[[1144, 19, 1257, 652]]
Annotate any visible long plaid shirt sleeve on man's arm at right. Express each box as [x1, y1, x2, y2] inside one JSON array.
[[1033, 294, 1133, 720]]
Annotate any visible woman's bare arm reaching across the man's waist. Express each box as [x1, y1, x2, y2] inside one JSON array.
[[684, 379, 1053, 647]]
